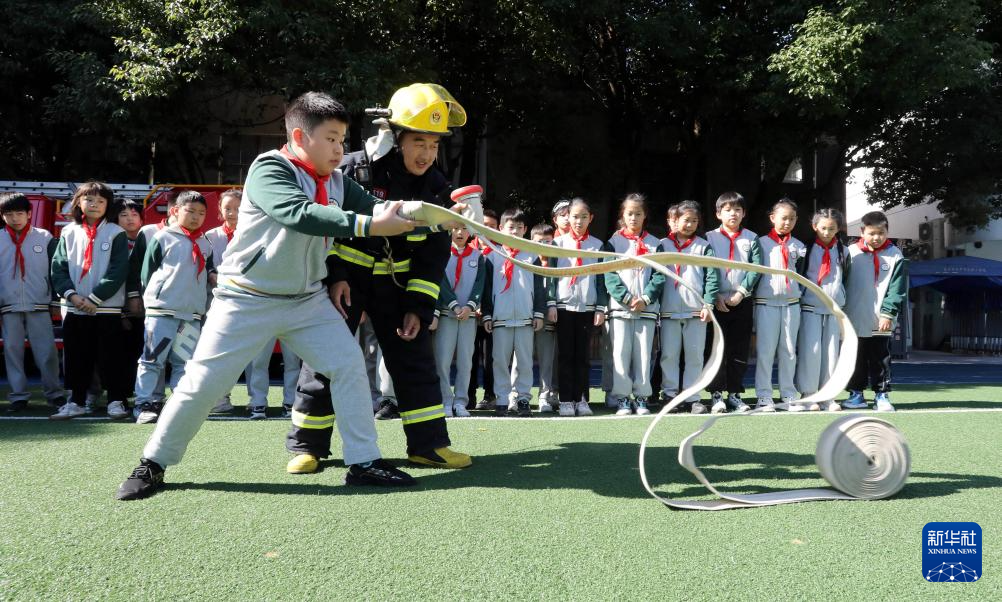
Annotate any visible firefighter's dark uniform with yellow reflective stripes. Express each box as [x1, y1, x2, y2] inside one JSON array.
[[286, 148, 452, 458]]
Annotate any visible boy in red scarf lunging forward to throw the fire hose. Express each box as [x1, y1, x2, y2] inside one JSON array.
[[116, 92, 415, 500]]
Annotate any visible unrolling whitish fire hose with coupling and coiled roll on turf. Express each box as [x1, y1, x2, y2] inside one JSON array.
[[411, 197, 911, 510]]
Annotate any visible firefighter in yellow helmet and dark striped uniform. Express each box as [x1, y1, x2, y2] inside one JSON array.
[[286, 83, 472, 473]]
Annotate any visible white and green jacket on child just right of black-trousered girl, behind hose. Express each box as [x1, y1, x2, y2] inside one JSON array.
[[601, 232, 664, 320]]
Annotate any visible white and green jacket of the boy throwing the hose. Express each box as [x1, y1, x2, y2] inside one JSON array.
[[217, 150, 380, 297]]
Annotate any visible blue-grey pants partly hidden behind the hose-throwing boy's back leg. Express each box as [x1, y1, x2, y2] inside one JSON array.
[[135, 316, 201, 405]]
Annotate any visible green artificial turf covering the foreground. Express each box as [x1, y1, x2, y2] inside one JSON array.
[[0, 387, 1002, 600]]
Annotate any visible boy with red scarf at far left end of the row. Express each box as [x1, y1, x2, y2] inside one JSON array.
[[0, 192, 66, 412]]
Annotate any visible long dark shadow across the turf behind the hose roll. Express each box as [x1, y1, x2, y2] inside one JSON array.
[[166, 443, 1002, 499]]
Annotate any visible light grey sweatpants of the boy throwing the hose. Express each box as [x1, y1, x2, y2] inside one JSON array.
[[143, 288, 382, 466]]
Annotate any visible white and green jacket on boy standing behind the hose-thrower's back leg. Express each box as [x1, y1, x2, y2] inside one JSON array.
[[141, 225, 214, 322]]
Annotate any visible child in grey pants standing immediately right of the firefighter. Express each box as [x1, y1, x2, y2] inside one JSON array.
[[433, 226, 487, 418]]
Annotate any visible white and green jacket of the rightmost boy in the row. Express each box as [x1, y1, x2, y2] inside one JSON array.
[[846, 238, 908, 339]]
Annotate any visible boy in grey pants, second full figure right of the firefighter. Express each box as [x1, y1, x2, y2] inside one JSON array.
[[483, 208, 556, 417]]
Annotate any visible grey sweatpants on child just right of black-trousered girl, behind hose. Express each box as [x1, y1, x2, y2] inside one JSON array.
[[609, 318, 654, 400]]
